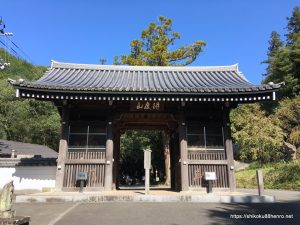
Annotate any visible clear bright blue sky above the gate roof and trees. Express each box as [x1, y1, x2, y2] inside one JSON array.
[[0, 0, 299, 84]]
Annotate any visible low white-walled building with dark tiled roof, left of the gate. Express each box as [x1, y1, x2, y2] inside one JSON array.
[[0, 140, 58, 191]]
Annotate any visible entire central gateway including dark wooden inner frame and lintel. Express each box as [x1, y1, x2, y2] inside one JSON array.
[[113, 112, 180, 190]]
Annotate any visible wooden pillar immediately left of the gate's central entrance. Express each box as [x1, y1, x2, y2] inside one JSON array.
[[104, 120, 114, 191]]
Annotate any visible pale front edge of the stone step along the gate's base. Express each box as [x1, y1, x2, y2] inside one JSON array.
[[16, 194, 275, 203]]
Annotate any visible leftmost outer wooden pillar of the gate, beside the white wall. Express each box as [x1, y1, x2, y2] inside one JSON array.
[[55, 105, 69, 191]]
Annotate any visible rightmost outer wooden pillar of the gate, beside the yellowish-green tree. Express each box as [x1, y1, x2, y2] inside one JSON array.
[[223, 103, 236, 191]]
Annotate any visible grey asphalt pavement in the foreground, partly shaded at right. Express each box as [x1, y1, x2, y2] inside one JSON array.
[[14, 190, 300, 225]]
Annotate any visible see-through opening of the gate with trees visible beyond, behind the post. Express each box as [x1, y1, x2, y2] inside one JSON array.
[[116, 130, 170, 190]]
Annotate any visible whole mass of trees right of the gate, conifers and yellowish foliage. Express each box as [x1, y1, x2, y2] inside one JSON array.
[[231, 7, 300, 163]]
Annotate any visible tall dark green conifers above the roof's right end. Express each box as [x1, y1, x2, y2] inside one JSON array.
[[263, 7, 300, 98]]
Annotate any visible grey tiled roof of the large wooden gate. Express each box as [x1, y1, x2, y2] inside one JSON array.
[[14, 61, 280, 94]]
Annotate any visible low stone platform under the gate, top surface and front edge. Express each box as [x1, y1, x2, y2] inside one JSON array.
[[16, 190, 275, 203]]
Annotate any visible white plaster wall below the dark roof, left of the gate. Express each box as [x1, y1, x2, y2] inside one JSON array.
[[0, 166, 56, 191]]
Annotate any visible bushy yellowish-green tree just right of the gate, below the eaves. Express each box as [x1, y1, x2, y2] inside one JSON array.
[[230, 104, 284, 163]]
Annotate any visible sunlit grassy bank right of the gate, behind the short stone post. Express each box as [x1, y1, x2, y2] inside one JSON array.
[[236, 160, 300, 190]]
